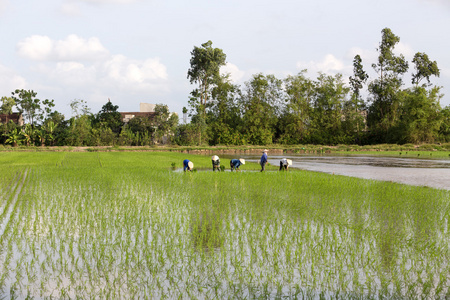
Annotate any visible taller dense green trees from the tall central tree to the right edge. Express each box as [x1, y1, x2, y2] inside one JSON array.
[[183, 28, 450, 145]]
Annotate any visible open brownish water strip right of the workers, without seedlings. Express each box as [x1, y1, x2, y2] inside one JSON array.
[[221, 153, 450, 190]]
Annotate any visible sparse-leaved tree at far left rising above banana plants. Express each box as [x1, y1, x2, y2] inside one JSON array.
[[12, 89, 55, 126]]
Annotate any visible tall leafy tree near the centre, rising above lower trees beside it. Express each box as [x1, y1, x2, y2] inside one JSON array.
[[187, 41, 226, 115]]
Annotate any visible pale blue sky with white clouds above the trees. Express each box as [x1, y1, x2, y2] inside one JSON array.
[[0, 0, 450, 118]]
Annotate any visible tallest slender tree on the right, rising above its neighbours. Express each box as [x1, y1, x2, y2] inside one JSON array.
[[368, 28, 408, 142]]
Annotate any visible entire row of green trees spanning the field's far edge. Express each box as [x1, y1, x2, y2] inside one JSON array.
[[0, 28, 450, 146]]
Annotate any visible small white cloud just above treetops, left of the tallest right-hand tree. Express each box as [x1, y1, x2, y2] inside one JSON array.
[[297, 54, 352, 75]]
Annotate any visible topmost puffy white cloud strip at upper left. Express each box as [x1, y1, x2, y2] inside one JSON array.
[[17, 34, 108, 61]]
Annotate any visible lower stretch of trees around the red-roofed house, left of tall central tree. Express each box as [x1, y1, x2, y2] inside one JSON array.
[[0, 90, 178, 146]]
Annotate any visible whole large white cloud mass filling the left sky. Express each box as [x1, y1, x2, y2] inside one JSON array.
[[15, 35, 169, 109]]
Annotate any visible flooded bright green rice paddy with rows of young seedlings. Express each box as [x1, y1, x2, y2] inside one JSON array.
[[0, 152, 450, 299]]
